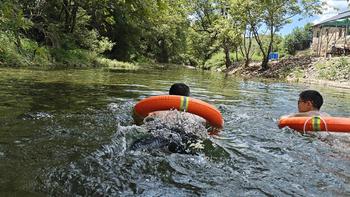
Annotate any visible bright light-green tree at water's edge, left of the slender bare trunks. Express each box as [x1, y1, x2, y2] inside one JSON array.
[[190, 0, 242, 68]]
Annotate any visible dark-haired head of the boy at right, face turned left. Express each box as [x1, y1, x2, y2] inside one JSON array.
[[298, 90, 323, 112]]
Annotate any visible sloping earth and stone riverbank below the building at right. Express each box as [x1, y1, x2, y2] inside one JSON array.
[[225, 56, 350, 89]]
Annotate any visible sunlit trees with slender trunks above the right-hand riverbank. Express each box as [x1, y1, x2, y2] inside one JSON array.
[[187, 0, 322, 70]]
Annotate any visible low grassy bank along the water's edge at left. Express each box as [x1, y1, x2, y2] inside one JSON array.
[[0, 31, 137, 69]]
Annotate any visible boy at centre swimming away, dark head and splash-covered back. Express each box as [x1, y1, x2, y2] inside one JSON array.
[[131, 83, 208, 153]]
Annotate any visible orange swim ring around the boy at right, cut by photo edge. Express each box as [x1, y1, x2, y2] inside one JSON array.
[[278, 116, 350, 133]]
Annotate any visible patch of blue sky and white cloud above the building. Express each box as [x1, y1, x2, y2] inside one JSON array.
[[279, 0, 348, 35]]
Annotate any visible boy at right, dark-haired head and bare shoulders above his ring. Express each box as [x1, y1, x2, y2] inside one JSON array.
[[281, 90, 330, 118]]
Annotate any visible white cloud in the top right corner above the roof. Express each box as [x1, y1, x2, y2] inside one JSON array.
[[313, 0, 349, 24]]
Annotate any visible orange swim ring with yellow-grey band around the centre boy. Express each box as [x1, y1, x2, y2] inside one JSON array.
[[134, 95, 224, 129]]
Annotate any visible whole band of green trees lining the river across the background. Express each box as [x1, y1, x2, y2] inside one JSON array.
[[0, 0, 321, 69]]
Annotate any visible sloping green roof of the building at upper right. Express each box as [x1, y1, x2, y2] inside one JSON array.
[[313, 10, 350, 27]]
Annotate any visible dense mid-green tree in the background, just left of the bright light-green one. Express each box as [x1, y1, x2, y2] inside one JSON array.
[[141, 1, 189, 63]]
